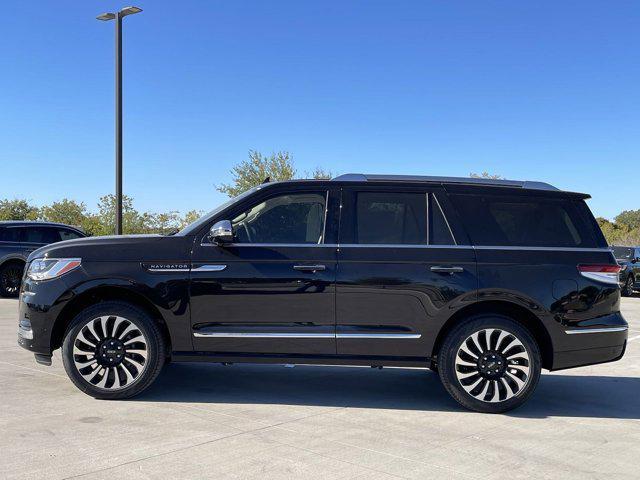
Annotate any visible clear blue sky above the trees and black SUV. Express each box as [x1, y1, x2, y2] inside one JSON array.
[[0, 0, 640, 217]]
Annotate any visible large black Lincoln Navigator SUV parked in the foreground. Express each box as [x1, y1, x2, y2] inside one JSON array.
[[19, 174, 628, 412]]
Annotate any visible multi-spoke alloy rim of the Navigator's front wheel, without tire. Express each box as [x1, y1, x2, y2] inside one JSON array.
[[73, 315, 149, 390]]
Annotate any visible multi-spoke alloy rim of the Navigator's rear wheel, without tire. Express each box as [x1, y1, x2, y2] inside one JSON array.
[[455, 328, 531, 403]]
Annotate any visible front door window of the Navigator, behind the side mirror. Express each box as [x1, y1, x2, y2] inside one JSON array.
[[231, 192, 327, 244]]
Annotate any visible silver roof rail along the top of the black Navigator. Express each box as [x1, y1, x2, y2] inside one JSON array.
[[331, 173, 558, 190]]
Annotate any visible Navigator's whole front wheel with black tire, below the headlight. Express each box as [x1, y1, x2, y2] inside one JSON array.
[[62, 301, 165, 400]]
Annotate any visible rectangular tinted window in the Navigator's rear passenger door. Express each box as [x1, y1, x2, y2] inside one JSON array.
[[354, 192, 427, 245]]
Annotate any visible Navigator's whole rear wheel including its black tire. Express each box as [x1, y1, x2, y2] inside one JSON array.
[[438, 315, 541, 413]]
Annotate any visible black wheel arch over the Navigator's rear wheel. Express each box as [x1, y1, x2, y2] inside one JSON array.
[[431, 300, 553, 369]]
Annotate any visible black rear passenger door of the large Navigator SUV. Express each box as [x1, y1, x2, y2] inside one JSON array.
[[336, 186, 478, 357]]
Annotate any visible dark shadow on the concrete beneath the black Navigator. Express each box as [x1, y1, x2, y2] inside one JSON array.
[[135, 363, 640, 419]]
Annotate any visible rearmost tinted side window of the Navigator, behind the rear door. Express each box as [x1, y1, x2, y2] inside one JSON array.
[[451, 195, 597, 247]]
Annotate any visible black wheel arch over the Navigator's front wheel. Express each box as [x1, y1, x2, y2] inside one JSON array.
[[51, 285, 171, 357]]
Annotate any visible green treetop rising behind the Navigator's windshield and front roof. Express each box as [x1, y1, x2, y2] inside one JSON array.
[[216, 150, 296, 197]]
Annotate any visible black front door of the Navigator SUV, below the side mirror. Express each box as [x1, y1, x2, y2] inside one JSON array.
[[191, 187, 336, 355]]
